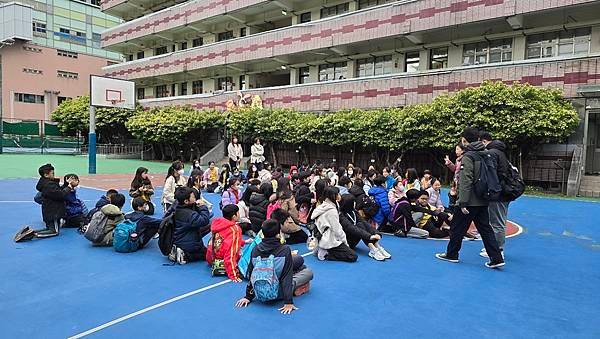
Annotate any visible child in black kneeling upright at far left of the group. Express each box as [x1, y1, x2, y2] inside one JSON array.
[[34, 164, 75, 238]]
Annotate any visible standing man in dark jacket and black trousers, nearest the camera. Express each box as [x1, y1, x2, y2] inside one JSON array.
[[435, 128, 504, 268]]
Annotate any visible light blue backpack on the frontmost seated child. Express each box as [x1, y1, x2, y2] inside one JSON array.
[[250, 254, 279, 302]]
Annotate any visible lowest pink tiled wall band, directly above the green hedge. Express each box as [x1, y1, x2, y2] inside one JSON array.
[[141, 58, 600, 111]]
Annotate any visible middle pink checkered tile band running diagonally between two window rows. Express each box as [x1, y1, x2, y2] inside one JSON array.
[[105, 0, 590, 79]]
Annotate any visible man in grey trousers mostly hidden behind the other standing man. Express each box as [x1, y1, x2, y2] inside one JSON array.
[[479, 132, 510, 258]]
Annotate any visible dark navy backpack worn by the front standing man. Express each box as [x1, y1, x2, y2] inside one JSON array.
[[465, 151, 502, 201]]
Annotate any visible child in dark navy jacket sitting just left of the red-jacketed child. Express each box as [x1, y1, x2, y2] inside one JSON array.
[[169, 187, 210, 265]]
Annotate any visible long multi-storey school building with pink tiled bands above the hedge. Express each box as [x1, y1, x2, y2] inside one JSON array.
[[101, 0, 600, 178]]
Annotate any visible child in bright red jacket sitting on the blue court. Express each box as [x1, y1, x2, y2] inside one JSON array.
[[206, 205, 252, 282]]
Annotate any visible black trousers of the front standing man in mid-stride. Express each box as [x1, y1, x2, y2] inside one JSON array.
[[446, 206, 504, 263]]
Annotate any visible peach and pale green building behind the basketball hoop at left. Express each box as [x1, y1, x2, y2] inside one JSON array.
[[0, 0, 122, 121]]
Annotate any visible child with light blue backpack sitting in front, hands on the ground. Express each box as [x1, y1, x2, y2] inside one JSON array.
[[235, 219, 313, 314]]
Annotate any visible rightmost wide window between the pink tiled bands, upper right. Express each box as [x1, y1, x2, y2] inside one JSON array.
[[526, 27, 591, 59]]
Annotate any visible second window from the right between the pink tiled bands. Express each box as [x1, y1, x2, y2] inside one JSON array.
[[463, 39, 512, 65]]
